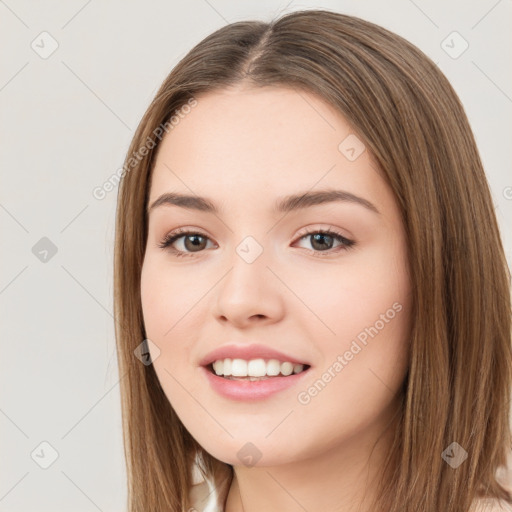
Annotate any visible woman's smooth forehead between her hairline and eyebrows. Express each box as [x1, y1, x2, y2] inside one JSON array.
[[149, 87, 392, 215]]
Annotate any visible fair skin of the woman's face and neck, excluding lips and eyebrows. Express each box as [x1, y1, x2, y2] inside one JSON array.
[[141, 86, 410, 512]]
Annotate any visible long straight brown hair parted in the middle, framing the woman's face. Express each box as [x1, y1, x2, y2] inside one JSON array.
[[114, 10, 512, 512]]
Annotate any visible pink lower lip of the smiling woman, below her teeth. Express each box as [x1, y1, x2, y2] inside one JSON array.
[[201, 366, 311, 401]]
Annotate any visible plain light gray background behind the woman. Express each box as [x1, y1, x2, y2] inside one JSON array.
[[0, 0, 512, 512]]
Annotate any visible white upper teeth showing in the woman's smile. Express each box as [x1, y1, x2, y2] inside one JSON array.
[[213, 358, 304, 380]]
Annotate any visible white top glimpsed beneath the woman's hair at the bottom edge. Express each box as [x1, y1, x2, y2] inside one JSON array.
[[190, 456, 512, 512]]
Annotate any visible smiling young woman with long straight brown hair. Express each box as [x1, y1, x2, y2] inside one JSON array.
[[114, 10, 512, 512]]
